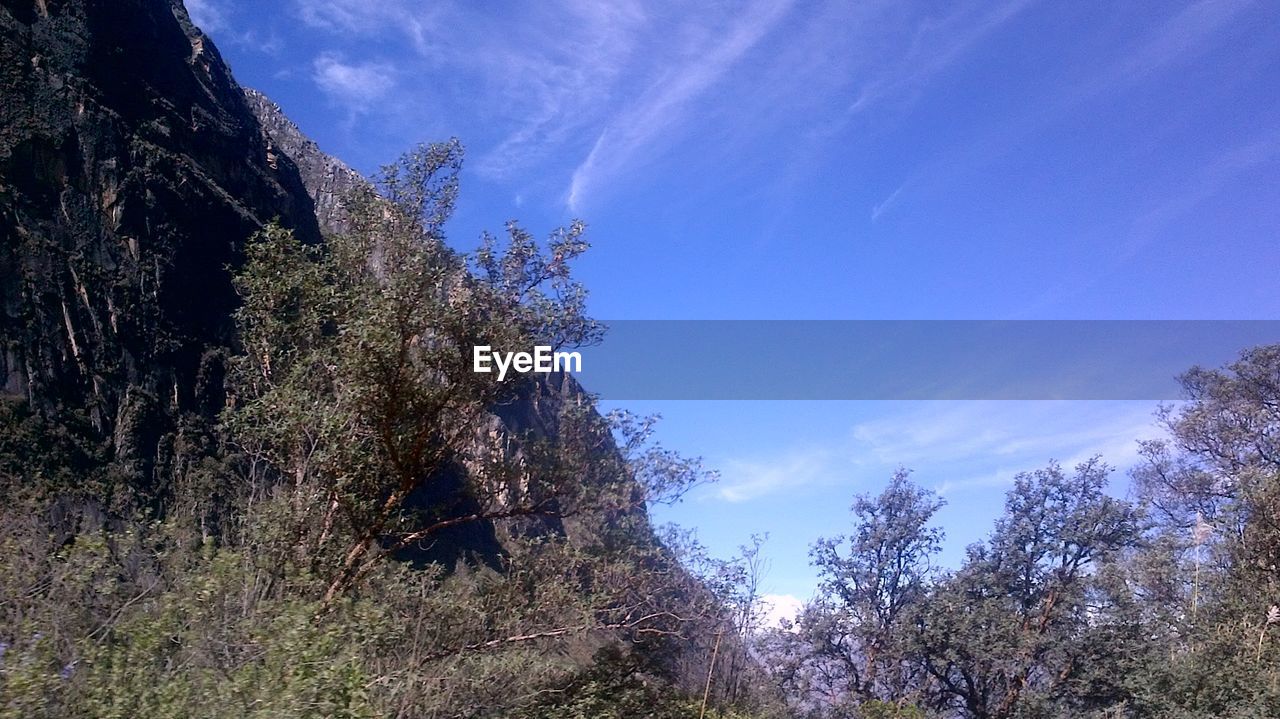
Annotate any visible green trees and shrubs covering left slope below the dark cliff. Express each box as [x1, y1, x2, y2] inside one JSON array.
[[0, 142, 727, 719]]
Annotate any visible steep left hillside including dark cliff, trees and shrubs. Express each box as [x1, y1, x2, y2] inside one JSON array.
[[0, 0, 768, 716]]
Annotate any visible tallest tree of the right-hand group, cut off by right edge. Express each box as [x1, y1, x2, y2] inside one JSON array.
[[1134, 345, 1280, 718]]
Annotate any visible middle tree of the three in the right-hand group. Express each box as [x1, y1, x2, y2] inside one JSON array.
[[914, 459, 1138, 719]]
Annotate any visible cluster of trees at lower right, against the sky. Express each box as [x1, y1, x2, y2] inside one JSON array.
[[759, 347, 1280, 719]]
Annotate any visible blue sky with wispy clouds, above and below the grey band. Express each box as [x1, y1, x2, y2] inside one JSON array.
[[187, 0, 1280, 616]]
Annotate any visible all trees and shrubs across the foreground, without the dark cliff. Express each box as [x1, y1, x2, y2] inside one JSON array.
[[0, 138, 1280, 719]]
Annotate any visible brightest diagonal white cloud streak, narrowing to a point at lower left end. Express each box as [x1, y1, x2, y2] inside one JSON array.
[[567, 1, 790, 211]]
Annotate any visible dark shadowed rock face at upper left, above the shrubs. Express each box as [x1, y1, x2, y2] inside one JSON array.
[[0, 0, 320, 484]]
